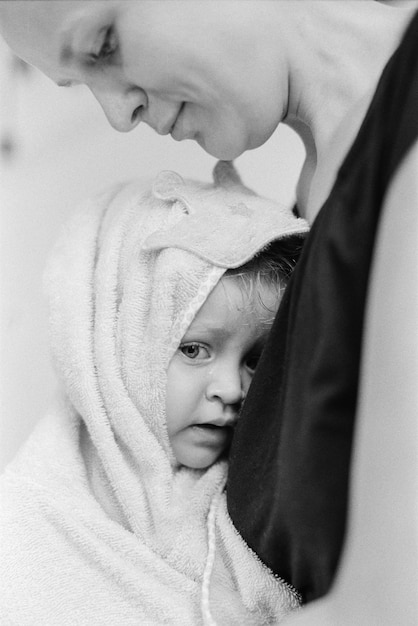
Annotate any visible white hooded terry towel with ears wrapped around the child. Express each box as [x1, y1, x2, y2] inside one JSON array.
[[0, 162, 307, 626]]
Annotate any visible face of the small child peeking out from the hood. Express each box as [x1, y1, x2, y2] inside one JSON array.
[[166, 277, 279, 469]]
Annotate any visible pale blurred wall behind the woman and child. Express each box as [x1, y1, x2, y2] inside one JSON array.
[[0, 40, 304, 469]]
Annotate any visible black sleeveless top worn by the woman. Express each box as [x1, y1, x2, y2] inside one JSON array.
[[227, 9, 418, 601]]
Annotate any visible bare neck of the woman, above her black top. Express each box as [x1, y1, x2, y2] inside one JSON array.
[[280, 0, 412, 222]]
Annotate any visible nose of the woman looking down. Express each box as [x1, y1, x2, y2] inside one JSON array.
[[90, 87, 148, 133]]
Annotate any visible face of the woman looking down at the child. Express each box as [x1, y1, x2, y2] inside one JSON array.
[[1, 0, 284, 159]]
